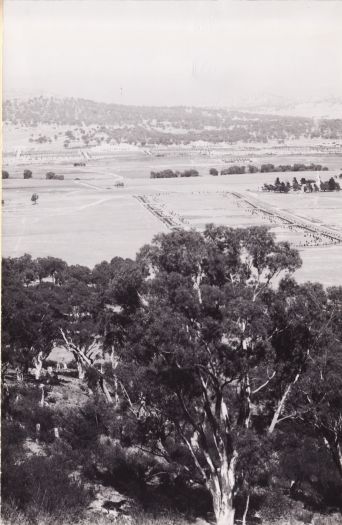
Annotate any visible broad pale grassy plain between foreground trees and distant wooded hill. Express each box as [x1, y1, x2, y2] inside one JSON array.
[[2, 154, 342, 285]]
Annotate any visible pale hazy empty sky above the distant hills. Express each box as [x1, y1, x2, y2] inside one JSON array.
[[3, 0, 342, 107]]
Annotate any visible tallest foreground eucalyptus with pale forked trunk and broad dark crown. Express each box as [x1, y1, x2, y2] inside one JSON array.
[[117, 226, 306, 525]]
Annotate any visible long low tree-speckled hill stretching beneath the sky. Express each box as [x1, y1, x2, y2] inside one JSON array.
[[3, 96, 342, 144]]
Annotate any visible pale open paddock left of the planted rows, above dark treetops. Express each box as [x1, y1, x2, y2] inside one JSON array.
[[2, 181, 168, 266]]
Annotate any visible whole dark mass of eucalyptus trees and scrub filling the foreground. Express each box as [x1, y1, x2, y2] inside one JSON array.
[[2, 225, 342, 525]]
